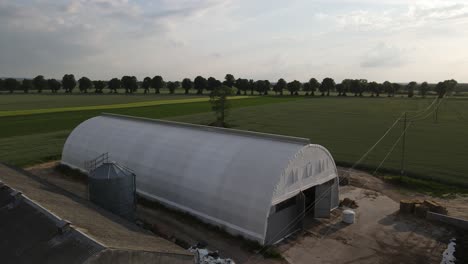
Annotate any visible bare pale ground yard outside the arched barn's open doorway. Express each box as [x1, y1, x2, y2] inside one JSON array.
[[280, 186, 452, 264]]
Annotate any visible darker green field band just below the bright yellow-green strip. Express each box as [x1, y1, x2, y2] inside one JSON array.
[[0, 97, 302, 166]]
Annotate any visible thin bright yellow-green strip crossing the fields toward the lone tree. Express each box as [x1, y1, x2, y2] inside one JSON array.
[[0, 96, 255, 117]]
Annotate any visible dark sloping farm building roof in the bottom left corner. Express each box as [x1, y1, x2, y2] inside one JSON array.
[[0, 163, 193, 263]]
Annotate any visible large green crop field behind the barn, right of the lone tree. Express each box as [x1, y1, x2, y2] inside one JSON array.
[[171, 98, 468, 186]]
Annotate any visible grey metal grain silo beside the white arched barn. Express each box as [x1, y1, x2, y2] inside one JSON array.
[[88, 162, 136, 219]]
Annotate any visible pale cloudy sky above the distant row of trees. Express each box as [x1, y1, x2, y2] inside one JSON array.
[[0, 0, 468, 82]]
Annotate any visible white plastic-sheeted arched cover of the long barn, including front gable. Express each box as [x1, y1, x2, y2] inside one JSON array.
[[62, 114, 337, 243]]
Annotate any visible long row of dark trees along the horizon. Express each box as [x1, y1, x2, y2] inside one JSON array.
[[0, 74, 458, 97]]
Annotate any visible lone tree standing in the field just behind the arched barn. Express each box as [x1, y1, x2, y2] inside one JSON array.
[[210, 85, 233, 127]]
